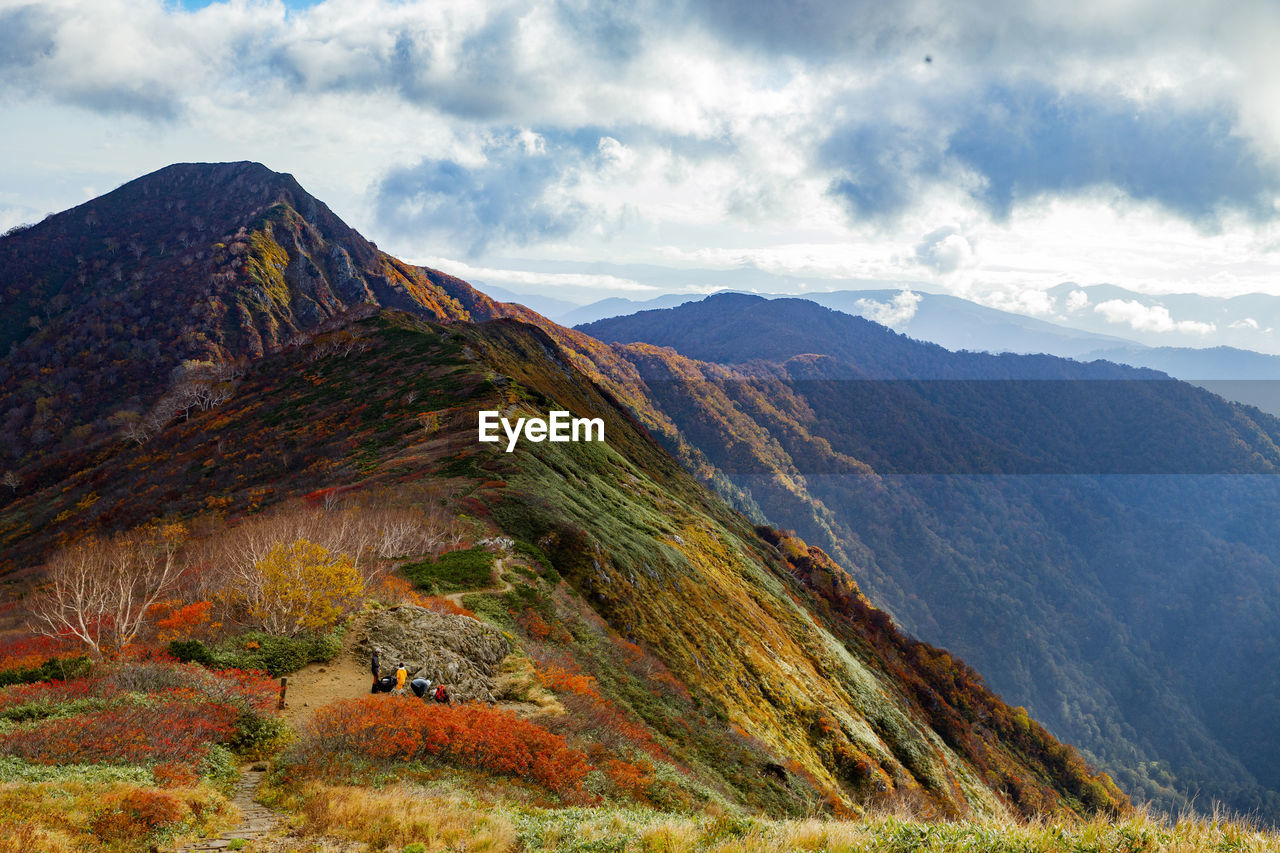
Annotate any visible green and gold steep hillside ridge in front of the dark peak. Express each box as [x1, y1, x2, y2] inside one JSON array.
[[0, 313, 1125, 815]]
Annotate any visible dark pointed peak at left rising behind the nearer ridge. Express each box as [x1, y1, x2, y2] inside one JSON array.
[[0, 163, 545, 466]]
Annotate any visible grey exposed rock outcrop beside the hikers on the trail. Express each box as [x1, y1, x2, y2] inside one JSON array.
[[355, 606, 511, 702]]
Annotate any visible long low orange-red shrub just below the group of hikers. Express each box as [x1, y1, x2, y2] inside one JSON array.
[[310, 695, 590, 793]]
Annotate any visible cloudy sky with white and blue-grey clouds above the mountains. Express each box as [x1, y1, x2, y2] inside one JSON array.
[[0, 0, 1280, 343]]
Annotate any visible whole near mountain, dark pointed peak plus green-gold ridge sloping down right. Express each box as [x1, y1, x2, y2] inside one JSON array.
[[0, 164, 1128, 816]]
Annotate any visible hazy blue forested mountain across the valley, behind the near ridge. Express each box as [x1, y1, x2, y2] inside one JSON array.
[[584, 296, 1280, 820]]
